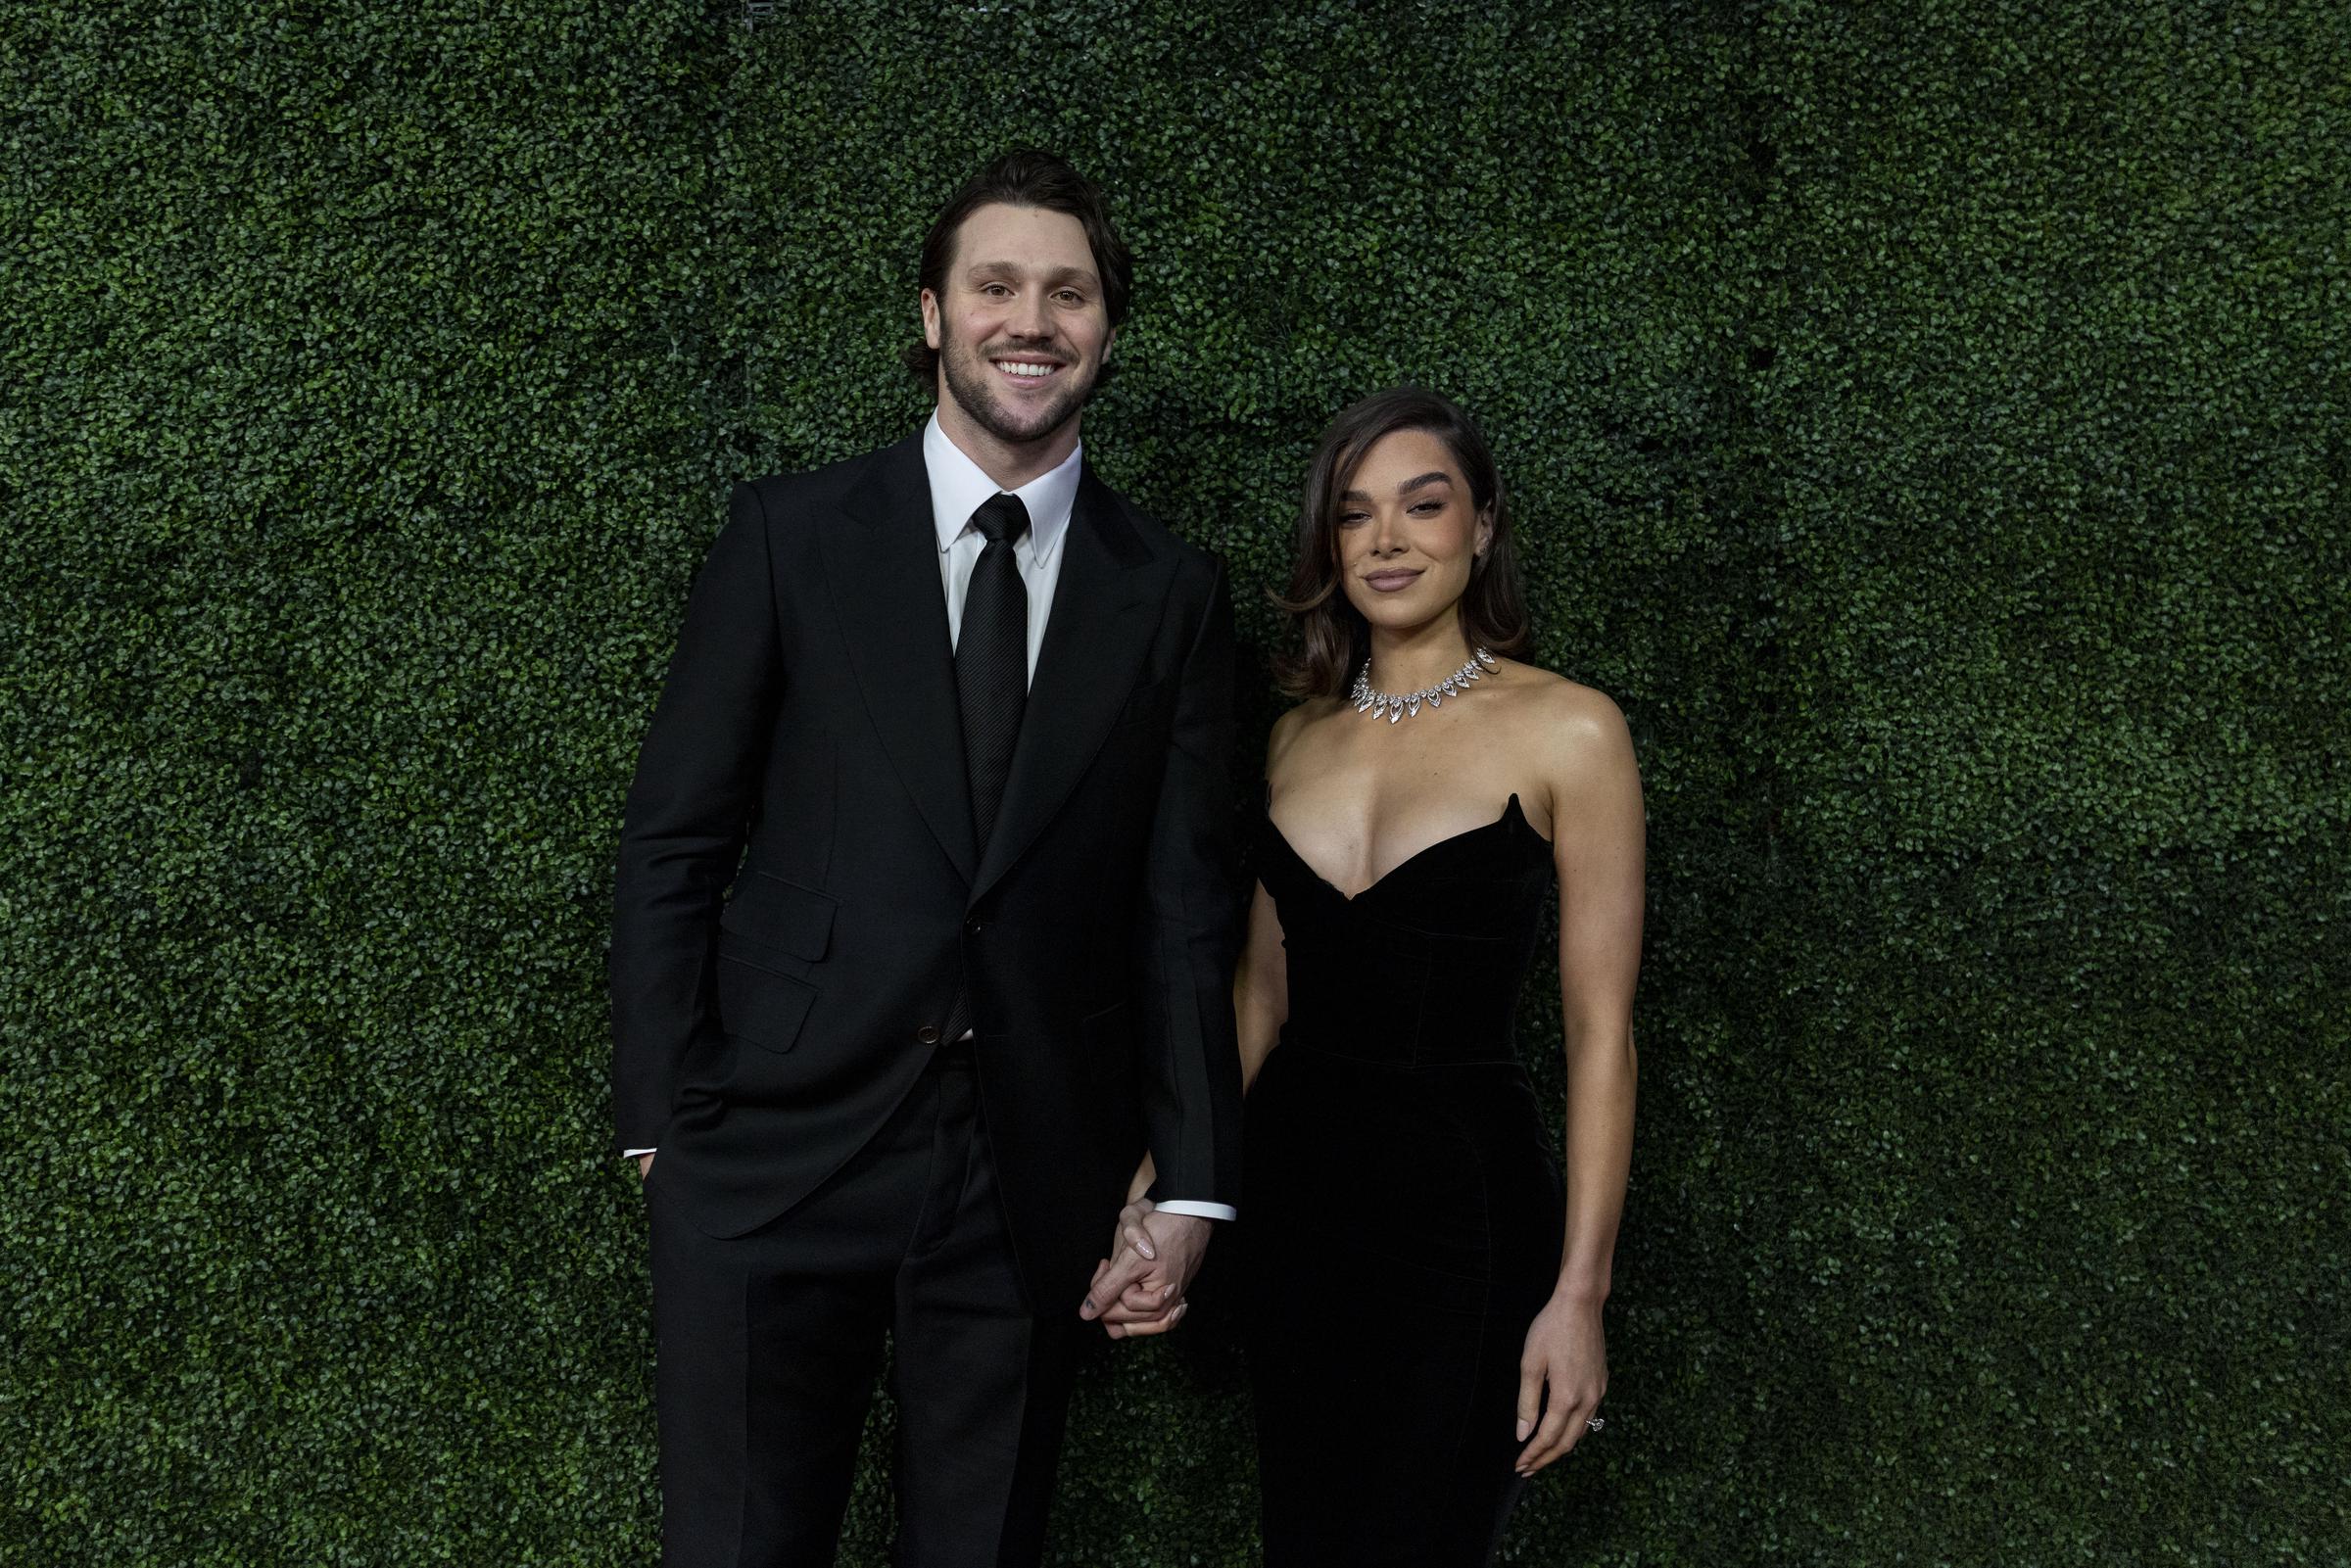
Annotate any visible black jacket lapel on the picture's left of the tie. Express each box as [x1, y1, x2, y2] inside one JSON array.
[[818, 435, 981, 881]]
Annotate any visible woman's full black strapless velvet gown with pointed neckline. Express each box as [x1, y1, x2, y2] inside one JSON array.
[[1241, 794, 1563, 1568]]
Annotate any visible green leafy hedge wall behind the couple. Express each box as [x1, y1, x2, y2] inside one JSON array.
[[0, 0, 2351, 1568]]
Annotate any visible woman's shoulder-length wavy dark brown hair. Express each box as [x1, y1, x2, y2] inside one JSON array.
[[1271, 386, 1528, 698]]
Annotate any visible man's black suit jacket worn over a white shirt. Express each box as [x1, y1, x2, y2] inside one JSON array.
[[611, 425, 1241, 1311]]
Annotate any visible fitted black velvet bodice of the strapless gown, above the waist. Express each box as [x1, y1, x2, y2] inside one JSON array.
[[1258, 794, 1552, 1068]]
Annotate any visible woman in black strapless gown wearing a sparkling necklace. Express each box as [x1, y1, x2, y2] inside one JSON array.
[[1105, 390, 1644, 1568]]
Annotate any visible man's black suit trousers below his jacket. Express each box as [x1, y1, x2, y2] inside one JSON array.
[[647, 1044, 1077, 1568]]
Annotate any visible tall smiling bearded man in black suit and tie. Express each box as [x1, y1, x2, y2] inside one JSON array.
[[611, 153, 1241, 1568]]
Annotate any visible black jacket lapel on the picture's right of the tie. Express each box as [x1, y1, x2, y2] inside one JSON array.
[[971, 468, 1176, 900]]
